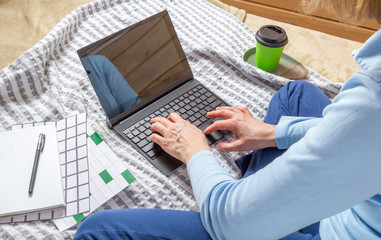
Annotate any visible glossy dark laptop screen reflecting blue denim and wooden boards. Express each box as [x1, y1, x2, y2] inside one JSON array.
[[78, 11, 192, 125]]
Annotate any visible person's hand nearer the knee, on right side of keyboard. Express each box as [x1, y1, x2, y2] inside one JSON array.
[[204, 107, 276, 152]]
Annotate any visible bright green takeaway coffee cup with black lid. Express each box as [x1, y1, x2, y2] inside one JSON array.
[[255, 25, 288, 72]]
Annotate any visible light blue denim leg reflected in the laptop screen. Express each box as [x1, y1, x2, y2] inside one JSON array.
[[81, 55, 141, 119]]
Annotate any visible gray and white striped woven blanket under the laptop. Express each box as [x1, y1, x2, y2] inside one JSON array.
[[0, 0, 341, 239]]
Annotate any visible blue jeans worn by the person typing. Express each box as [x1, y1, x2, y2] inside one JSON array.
[[74, 81, 330, 240]]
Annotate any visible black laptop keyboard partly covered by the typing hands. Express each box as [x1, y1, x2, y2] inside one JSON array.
[[123, 85, 225, 159]]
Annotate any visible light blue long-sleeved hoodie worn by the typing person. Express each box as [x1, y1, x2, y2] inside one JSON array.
[[187, 30, 381, 240]]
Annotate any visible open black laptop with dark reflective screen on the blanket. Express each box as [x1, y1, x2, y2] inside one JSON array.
[[77, 10, 228, 176]]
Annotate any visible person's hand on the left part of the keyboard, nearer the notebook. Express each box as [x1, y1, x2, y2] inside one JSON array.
[[150, 113, 211, 164]]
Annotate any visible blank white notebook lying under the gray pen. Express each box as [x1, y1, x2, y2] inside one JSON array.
[[0, 125, 65, 217]]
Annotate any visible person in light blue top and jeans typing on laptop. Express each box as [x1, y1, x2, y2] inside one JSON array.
[[75, 0, 381, 239]]
